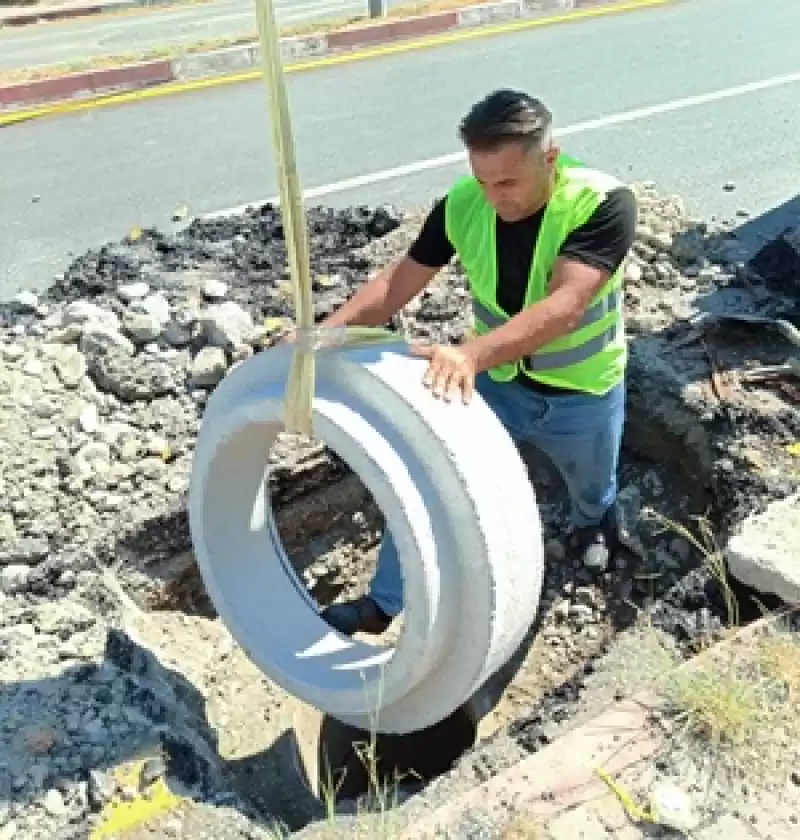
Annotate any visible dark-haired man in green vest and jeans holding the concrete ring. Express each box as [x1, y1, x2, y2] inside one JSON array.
[[310, 90, 636, 635]]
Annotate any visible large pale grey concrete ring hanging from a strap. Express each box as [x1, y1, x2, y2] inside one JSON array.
[[189, 344, 544, 733]]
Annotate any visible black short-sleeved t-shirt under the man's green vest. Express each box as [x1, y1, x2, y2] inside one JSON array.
[[408, 187, 636, 316]]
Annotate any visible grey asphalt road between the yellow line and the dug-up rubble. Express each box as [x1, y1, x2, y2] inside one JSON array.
[[0, 0, 800, 298]]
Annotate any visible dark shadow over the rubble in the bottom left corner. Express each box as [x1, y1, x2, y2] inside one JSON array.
[[0, 628, 272, 838]]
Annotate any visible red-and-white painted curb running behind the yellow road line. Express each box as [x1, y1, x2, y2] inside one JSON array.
[[0, 0, 617, 114]]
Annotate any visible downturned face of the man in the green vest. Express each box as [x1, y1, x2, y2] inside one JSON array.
[[469, 142, 558, 222]]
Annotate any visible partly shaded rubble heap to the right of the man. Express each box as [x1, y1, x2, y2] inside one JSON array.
[[625, 185, 800, 525]]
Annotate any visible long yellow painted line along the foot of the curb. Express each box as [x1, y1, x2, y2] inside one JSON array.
[[0, 0, 677, 127]]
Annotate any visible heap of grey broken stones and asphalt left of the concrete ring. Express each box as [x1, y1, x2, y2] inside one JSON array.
[[0, 208, 398, 595]]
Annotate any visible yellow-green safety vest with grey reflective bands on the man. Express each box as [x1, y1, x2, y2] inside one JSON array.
[[445, 155, 627, 395]]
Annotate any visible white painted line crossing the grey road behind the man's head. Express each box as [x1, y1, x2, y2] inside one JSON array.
[[202, 72, 800, 219]]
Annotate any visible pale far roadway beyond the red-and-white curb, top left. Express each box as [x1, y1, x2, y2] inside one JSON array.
[[0, 0, 408, 70]]
